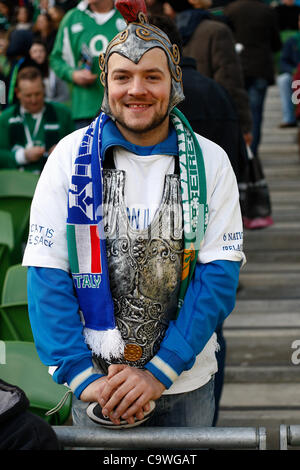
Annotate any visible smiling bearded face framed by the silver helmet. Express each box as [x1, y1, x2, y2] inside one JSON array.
[[107, 48, 171, 145]]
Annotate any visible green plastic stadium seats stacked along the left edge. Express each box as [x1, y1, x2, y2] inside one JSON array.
[[0, 170, 71, 425]]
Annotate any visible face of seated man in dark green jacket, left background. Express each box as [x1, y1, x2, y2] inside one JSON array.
[[16, 77, 44, 114]]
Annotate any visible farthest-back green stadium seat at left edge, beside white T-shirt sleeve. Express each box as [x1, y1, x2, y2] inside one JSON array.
[[0, 170, 39, 263]]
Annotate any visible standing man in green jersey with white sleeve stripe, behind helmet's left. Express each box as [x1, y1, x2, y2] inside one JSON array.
[[50, 0, 125, 128]]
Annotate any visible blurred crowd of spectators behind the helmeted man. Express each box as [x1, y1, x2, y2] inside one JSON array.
[[0, 0, 300, 220]]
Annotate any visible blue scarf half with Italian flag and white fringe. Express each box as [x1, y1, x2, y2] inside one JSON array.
[[67, 113, 123, 359]]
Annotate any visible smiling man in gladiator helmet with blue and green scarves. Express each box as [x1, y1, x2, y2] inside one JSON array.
[[23, 4, 244, 428]]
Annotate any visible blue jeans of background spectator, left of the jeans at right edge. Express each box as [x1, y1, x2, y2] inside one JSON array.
[[246, 78, 268, 155]]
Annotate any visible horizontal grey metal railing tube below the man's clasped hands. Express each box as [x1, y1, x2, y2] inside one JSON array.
[[53, 426, 266, 450]]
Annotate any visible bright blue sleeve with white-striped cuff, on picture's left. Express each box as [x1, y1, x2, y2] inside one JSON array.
[[28, 266, 102, 398]]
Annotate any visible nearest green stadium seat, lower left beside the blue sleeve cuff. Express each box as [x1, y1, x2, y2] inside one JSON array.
[[0, 341, 72, 425]]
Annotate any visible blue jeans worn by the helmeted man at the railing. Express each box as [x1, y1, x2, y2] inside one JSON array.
[[72, 378, 215, 427]]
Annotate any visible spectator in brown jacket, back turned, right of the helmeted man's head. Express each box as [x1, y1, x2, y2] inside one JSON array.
[[164, 0, 252, 147]]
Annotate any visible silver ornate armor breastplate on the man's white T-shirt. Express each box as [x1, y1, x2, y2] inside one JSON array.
[[103, 169, 183, 367]]
